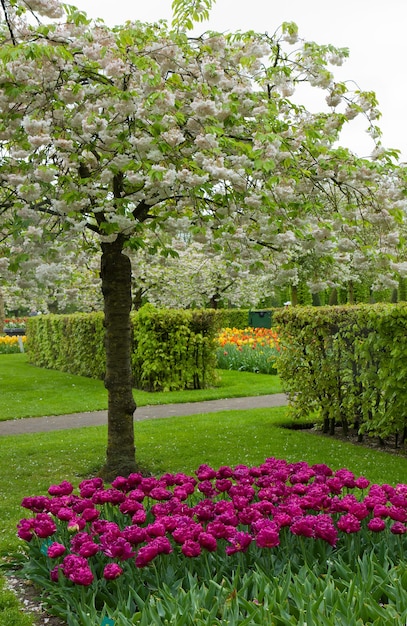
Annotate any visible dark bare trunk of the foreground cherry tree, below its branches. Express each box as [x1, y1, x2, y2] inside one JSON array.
[[100, 235, 137, 481]]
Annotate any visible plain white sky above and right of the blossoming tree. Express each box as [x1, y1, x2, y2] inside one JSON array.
[[75, 0, 407, 161]]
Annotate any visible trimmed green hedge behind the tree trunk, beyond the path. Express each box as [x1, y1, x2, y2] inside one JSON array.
[[27, 305, 219, 391]]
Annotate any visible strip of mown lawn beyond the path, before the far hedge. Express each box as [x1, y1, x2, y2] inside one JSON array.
[[0, 354, 281, 420]]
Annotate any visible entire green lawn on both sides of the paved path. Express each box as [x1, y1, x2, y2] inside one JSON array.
[[0, 355, 407, 626]]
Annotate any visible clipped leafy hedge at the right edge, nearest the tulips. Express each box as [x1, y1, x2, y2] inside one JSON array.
[[274, 303, 407, 445]]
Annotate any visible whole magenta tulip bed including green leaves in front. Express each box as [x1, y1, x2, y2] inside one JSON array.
[[18, 458, 407, 626]]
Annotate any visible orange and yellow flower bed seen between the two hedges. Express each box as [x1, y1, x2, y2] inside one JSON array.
[[216, 328, 280, 374]]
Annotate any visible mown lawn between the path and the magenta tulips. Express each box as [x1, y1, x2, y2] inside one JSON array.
[[0, 408, 407, 555]]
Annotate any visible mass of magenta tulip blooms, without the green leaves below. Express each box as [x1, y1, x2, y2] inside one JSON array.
[[18, 458, 407, 586]]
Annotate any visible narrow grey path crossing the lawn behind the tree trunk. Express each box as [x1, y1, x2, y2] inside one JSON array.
[[0, 393, 287, 436]]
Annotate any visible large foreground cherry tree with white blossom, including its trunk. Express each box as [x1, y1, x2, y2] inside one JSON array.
[[0, 0, 399, 477]]
